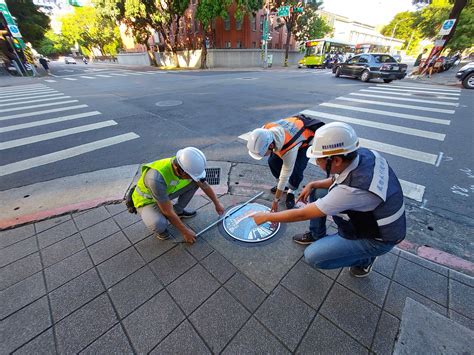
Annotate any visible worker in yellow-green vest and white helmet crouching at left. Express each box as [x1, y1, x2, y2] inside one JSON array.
[[132, 147, 224, 243]]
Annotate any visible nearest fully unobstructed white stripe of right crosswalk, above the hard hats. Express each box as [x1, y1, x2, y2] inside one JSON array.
[[301, 110, 446, 141]]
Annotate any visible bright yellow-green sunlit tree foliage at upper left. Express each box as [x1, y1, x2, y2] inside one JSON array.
[[61, 7, 121, 55]]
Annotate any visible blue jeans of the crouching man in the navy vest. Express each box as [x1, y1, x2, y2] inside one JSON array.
[[304, 189, 395, 269]]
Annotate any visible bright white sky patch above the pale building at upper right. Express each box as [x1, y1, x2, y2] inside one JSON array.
[[323, 0, 412, 26]]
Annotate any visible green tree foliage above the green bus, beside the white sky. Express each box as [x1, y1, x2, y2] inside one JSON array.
[[295, 2, 333, 48]]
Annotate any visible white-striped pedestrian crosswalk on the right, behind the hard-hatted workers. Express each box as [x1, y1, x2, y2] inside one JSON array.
[[239, 83, 461, 202]]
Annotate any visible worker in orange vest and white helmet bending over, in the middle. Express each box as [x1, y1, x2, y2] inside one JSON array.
[[247, 115, 324, 212]]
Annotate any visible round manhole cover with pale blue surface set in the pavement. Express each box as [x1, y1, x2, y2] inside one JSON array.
[[223, 203, 280, 243]]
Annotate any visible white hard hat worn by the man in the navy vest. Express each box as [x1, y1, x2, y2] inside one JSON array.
[[306, 122, 359, 159]]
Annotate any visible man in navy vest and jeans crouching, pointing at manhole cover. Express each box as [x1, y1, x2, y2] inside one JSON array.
[[253, 122, 406, 277]]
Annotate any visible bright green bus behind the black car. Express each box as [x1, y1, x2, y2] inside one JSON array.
[[298, 38, 355, 68]]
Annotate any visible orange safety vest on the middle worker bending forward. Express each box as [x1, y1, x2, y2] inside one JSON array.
[[263, 117, 314, 158]]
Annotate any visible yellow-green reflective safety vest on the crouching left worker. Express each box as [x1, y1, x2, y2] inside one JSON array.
[[132, 157, 192, 208]]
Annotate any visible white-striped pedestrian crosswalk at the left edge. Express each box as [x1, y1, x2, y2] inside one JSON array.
[[0, 84, 139, 177]]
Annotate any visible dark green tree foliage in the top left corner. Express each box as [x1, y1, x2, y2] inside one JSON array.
[[6, 0, 49, 47]]
